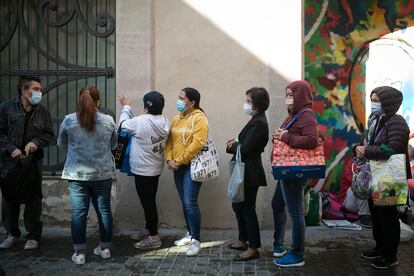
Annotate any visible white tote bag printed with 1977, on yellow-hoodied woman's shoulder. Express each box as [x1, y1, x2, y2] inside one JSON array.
[[183, 113, 219, 182]]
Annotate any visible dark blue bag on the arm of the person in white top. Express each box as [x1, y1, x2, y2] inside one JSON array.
[[112, 121, 131, 173]]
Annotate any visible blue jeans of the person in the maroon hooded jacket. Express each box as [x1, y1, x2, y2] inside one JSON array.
[[272, 180, 306, 257]]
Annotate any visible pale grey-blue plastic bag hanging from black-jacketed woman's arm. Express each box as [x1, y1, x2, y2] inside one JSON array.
[[226, 145, 245, 203]]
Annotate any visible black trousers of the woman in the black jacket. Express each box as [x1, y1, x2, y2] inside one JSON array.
[[232, 185, 261, 249]]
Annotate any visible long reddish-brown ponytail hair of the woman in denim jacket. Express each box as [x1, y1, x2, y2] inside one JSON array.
[[76, 86, 100, 132]]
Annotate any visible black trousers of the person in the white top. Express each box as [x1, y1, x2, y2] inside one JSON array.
[[135, 175, 160, 236]]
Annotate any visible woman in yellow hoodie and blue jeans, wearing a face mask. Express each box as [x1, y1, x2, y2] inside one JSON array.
[[166, 87, 208, 256]]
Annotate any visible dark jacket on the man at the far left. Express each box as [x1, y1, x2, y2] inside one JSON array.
[[0, 97, 54, 163]]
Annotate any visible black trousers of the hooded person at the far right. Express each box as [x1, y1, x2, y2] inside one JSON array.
[[368, 199, 401, 258]]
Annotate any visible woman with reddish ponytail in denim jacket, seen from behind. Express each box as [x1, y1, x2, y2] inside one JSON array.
[[57, 86, 117, 265]]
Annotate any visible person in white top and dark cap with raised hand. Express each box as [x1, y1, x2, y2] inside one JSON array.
[[119, 91, 169, 249]]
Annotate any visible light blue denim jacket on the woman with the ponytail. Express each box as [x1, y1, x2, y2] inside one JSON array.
[[57, 112, 117, 181]]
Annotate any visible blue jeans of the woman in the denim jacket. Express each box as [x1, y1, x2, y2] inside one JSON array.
[[69, 179, 112, 250]]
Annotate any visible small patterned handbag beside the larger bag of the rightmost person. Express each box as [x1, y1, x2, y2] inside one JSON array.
[[351, 158, 372, 200]]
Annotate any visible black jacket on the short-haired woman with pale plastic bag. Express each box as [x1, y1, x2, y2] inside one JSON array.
[[227, 113, 269, 186]]
